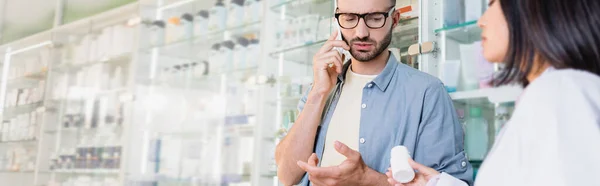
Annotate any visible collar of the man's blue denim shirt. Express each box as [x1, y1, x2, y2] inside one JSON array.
[[338, 52, 398, 92]]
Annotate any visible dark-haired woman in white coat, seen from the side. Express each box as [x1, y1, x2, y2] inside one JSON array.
[[387, 0, 600, 186]]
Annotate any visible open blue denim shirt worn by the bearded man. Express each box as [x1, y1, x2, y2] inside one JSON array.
[[298, 54, 473, 186]]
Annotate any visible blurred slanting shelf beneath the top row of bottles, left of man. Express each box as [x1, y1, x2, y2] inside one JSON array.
[[141, 21, 262, 60]]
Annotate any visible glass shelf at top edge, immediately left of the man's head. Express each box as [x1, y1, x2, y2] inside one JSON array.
[[271, 0, 333, 17]]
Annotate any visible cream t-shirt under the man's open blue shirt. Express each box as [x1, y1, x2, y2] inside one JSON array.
[[321, 68, 377, 167]]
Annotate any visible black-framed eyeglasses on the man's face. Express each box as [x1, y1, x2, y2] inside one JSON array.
[[335, 7, 395, 29]]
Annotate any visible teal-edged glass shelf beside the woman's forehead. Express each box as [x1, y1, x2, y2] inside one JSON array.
[[434, 20, 481, 44]]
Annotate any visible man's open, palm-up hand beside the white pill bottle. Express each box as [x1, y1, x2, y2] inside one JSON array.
[[298, 141, 374, 186]]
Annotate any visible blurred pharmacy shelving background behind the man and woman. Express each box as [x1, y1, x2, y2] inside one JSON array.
[[0, 0, 521, 186]]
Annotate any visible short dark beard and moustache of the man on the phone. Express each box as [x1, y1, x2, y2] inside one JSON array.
[[344, 29, 392, 62]]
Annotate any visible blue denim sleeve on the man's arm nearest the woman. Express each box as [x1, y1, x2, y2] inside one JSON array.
[[413, 81, 473, 185]]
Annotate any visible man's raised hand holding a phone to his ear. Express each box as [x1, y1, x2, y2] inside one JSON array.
[[313, 31, 350, 96]]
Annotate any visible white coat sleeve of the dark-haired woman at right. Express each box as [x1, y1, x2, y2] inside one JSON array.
[[513, 72, 600, 185]]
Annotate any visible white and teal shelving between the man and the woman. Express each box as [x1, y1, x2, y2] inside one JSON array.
[[420, 0, 523, 171]]
